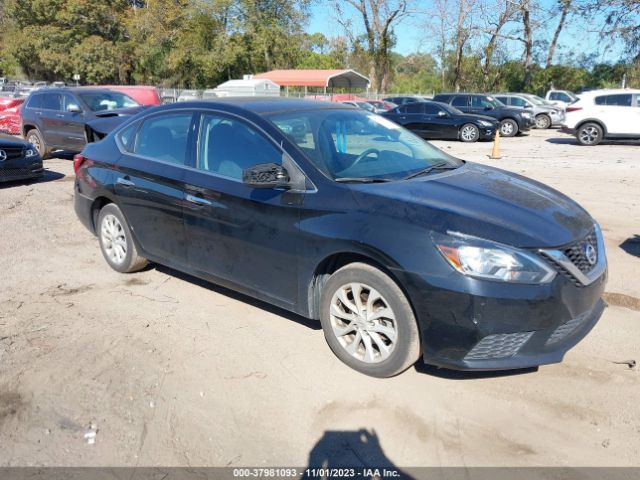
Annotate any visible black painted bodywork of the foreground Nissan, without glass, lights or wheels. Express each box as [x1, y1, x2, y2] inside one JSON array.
[[75, 99, 606, 369]]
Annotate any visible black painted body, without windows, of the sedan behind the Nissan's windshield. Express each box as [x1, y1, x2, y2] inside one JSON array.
[[382, 101, 499, 140]]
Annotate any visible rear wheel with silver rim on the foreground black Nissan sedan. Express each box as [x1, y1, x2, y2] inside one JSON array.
[[96, 203, 149, 273]]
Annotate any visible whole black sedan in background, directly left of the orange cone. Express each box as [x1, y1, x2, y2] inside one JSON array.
[[383, 102, 500, 142]]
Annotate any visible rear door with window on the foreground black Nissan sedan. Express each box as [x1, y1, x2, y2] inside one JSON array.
[[115, 110, 194, 268]]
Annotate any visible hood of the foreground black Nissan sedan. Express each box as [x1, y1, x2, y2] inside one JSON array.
[[353, 163, 594, 248]]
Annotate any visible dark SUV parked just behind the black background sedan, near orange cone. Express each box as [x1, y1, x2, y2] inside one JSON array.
[[433, 93, 535, 137]]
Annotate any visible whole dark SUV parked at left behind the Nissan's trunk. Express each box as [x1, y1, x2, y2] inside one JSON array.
[[22, 87, 143, 158]]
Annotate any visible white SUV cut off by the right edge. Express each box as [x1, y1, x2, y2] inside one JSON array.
[[562, 89, 640, 145]]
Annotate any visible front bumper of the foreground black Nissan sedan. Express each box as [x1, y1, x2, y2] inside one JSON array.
[[398, 262, 607, 370]]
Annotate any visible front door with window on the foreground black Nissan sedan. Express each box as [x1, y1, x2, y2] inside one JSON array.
[[184, 112, 305, 305]]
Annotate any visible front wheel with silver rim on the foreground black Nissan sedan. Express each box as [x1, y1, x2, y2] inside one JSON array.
[[320, 263, 420, 378]]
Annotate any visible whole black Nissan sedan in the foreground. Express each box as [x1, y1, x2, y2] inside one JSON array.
[[74, 98, 607, 377]]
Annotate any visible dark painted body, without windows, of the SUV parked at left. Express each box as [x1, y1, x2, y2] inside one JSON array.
[[22, 87, 145, 152]]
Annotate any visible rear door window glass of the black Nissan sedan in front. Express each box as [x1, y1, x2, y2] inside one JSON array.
[[134, 113, 192, 165]]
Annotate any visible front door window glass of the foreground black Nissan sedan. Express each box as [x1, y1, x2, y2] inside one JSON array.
[[198, 114, 282, 180]]
